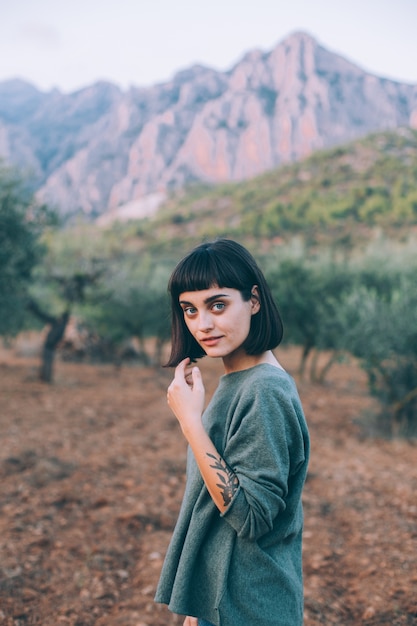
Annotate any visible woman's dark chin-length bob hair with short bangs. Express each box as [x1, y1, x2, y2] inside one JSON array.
[[166, 239, 283, 367]]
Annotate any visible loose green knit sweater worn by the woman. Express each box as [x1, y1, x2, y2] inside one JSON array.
[[155, 364, 309, 626]]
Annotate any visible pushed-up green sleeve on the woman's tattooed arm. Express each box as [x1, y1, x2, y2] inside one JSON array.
[[219, 370, 305, 541]]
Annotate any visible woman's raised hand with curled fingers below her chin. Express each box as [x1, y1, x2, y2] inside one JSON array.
[[167, 357, 205, 439]]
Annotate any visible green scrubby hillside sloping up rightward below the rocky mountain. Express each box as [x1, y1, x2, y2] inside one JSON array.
[[132, 128, 417, 248]]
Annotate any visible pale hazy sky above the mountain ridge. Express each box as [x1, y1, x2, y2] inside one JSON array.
[[0, 0, 417, 92]]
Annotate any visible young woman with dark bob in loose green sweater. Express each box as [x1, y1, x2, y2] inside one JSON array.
[[155, 239, 309, 626]]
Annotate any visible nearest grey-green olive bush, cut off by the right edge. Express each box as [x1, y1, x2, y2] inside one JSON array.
[[343, 276, 417, 437]]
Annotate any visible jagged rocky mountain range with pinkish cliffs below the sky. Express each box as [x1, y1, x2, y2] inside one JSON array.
[[0, 33, 417, 217]]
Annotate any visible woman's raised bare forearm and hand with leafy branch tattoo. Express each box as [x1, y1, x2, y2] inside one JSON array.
[[167, 359, 239, 513]]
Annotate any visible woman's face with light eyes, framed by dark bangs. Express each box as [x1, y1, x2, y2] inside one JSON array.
[[179, 286, 259, 371]]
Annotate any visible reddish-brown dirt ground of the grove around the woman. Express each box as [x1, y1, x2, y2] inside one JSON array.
[[0, 350, 417, 626]]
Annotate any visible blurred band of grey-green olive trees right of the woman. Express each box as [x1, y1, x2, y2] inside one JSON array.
[[268, 241, 417, 437]]
